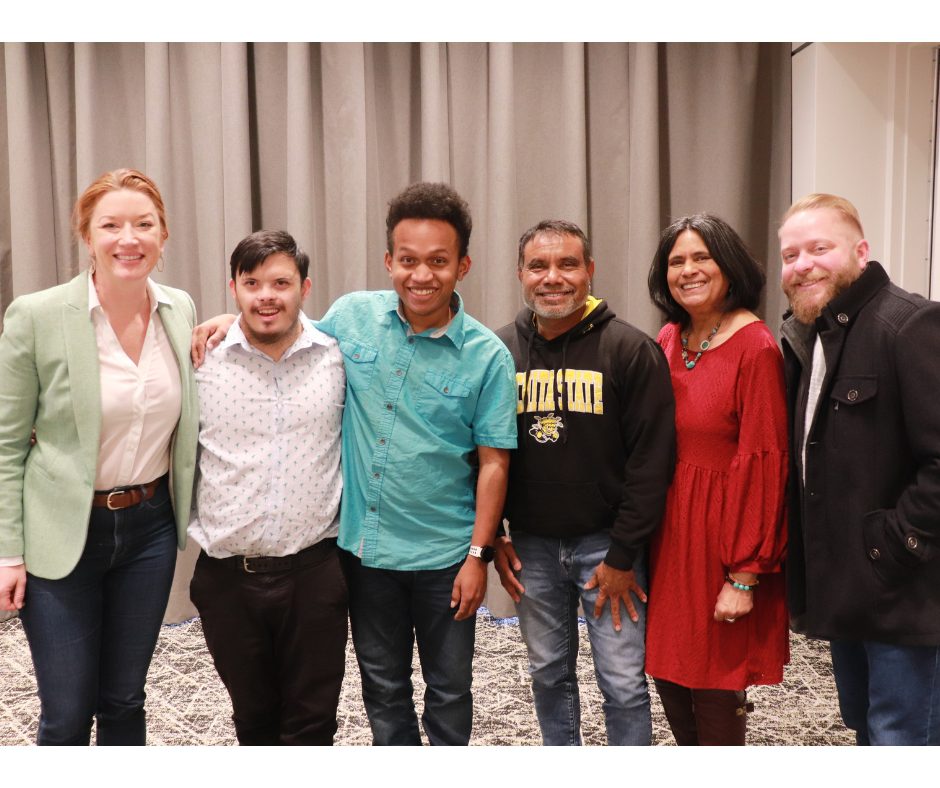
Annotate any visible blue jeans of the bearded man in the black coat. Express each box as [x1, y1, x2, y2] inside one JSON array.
[[830, 640, 940, 745]]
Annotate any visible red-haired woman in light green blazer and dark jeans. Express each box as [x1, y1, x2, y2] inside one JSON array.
[[0, 169, 198, 745]]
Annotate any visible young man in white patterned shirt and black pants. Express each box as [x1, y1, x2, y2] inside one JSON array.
[[189, 231, 347, 745]]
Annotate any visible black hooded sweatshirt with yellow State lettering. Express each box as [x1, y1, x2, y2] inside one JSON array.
[[497, 299, 675, 570]]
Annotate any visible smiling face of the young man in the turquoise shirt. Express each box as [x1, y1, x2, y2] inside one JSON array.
[[385, 219, 470, 334]]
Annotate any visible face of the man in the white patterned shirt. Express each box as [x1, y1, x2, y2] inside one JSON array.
[[229, 252, 311, 360]]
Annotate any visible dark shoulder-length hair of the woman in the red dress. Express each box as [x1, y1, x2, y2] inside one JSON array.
[[649, 213, 767, 326]]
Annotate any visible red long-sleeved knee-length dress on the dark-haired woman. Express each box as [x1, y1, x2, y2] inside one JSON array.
[[646, 322, 790, 690]]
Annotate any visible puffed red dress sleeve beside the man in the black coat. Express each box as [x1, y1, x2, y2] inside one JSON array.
[[721, 333, 788, 574]]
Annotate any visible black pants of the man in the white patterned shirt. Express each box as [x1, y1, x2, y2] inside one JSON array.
[[190, 540, 347, 745]]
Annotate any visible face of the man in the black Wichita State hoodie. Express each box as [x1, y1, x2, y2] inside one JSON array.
[[519, 232, 594, 336]]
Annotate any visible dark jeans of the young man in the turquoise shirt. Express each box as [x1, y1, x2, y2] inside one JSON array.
[[340, 550, 476, 745]]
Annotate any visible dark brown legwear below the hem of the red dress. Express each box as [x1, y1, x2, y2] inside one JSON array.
[[653, 677, 748, 747]]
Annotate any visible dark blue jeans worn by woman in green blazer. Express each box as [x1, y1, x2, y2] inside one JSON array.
[[20, 481, 176, 746]]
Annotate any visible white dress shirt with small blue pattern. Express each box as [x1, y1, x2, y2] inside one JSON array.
[[189, 319, 346, 558]]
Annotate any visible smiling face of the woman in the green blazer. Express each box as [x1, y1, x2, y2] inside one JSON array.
[[85, 189, 166, 286]]
